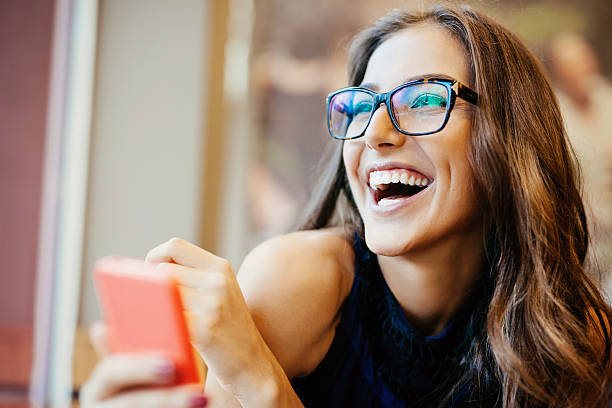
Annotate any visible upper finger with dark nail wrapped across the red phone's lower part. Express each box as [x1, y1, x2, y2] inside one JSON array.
[[84, 354, 175, 400]]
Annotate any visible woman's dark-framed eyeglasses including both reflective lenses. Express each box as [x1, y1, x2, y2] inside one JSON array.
[[327, 78, 478, 140]]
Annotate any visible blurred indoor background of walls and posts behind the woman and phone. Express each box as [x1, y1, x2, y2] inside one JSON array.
[[0, 0, 612, 407]]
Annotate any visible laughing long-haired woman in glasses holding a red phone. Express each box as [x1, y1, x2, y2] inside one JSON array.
[[82, 3, 612, 408]]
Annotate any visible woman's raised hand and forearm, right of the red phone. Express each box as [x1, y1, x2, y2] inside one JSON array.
[[146, 238, 294, 406]]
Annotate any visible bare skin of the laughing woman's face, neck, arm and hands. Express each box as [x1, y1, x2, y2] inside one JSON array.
[[82, 25, 483, 408]]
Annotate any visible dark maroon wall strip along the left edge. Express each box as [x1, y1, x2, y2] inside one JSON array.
[[0, 0, 55, 396]]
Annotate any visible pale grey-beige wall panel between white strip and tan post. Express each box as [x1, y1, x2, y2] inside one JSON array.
[[80, 0, 210, 325]]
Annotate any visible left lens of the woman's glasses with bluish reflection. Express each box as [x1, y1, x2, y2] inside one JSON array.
[[328, 90, 374, 139]]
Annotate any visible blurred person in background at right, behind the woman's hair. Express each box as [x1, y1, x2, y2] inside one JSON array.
[[549, 32, 612, 295]]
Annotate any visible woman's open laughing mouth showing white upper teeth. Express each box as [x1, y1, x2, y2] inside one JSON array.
[[369, 169, 432, 205]]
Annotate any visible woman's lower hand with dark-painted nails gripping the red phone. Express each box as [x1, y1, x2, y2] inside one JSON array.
[[80, 323, 207, 408]]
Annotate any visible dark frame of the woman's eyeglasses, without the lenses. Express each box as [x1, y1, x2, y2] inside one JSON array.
[[326, 78, 478, 140]]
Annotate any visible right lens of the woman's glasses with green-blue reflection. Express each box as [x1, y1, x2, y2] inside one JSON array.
[[391, 82, 450, 133]]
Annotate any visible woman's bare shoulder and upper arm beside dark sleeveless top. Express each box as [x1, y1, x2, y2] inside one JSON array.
[[238, 229, 354, 378]]
